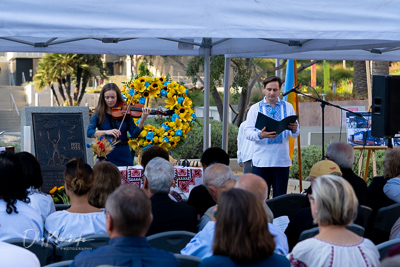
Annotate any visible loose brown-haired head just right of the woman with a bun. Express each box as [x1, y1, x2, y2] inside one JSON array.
[[88, 161, 121, 209]]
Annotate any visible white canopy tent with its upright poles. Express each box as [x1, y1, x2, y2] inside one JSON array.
[[0, 0, 400, 149]]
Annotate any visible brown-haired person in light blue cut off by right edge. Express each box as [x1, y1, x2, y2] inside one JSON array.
[[383, 147, 400, 203]]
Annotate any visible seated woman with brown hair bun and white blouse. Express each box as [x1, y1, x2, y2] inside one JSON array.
[[44, 158, 107, 244]]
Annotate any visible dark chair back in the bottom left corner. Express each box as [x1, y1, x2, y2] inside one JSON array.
[[4, 238, 54, 266]]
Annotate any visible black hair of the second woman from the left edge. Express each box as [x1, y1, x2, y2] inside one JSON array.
[[15, 152, 43, 189]]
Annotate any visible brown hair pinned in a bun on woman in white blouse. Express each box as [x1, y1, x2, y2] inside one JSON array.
[[64, 158, 93, 196]]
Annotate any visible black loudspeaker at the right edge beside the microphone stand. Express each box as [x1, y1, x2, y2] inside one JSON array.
[[371, 75, 400, 137]]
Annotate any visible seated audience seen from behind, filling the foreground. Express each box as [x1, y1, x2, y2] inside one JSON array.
[[0, 146, 400, 266]]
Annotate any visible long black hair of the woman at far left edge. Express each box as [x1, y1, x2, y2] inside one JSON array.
[[0, 153, 30, 214]]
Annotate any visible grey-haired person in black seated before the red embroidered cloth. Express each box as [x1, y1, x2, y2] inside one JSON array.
[[144, 157, 197, 236]]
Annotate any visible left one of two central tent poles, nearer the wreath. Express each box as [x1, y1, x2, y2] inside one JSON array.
[[203, 38, 211, 151]]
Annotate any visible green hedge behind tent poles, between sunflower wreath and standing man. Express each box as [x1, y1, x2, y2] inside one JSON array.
[[170, 119, 239, 159]]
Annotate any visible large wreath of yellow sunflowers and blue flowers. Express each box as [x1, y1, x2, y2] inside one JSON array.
[[122, 76, 196, 154]]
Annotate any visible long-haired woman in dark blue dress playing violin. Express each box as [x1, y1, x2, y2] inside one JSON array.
[[87, 83, 151, 166]]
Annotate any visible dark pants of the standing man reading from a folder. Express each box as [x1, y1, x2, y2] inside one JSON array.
[[253, 166, 289, 198]]
